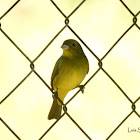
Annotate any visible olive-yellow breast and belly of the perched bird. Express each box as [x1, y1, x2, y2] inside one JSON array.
[[53, 56, 88, 91]]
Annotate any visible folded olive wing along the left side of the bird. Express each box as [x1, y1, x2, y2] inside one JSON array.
[[51, 57, 61, 89]]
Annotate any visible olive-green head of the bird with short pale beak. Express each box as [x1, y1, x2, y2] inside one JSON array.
[[61, 39, 84, 56]]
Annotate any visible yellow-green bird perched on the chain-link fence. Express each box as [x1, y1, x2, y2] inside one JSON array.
[[48, 39, 89, 120]]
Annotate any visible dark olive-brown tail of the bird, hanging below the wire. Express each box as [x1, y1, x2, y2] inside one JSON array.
[[48, 98, 62, 120]]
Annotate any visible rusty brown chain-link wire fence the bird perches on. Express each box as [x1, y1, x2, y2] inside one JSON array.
[[0, 0, 140, 140]]
